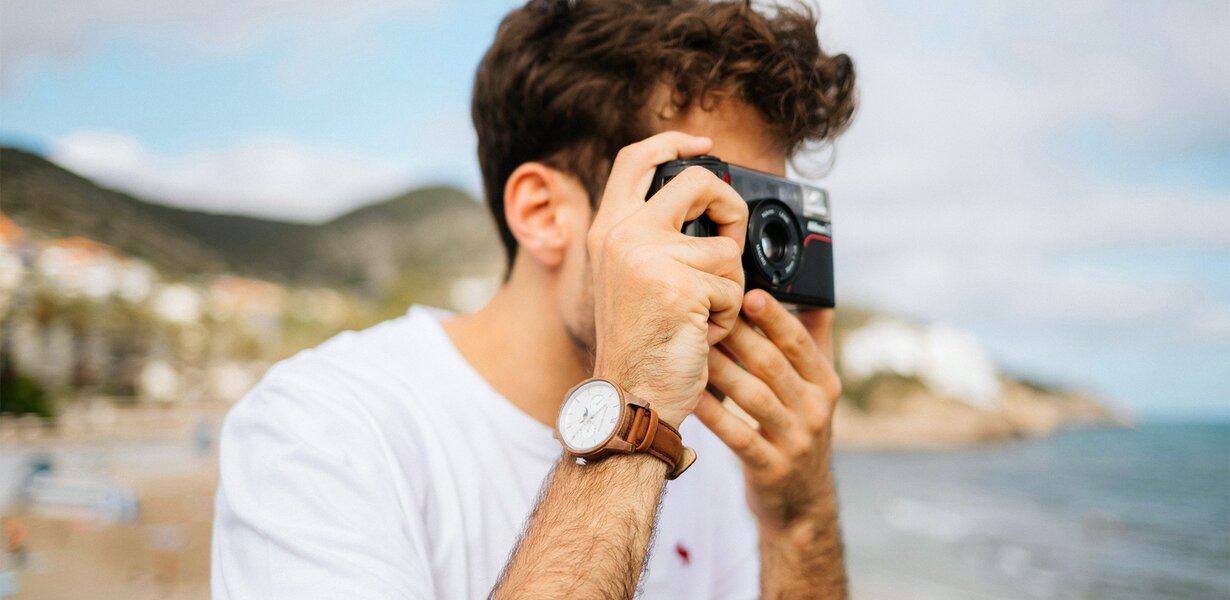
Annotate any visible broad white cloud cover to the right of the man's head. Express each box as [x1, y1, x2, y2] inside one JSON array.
[[804, 0, 1230, 401]]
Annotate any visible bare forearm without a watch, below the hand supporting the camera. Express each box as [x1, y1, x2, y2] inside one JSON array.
[[760, 477, 847, 600]]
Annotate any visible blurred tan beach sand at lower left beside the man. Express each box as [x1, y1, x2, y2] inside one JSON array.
[[0, 406, 225, 600]]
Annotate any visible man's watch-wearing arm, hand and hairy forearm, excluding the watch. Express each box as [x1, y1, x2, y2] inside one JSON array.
[[492, 132, 748, 599]]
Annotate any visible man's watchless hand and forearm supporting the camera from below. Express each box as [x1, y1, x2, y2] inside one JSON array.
[[696, 290, 845, 598]]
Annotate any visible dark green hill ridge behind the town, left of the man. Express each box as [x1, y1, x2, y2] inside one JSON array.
[[0, 148, 502, 291]]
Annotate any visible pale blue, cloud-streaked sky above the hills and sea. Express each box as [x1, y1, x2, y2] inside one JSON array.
[[0, 0, 1230, 420]]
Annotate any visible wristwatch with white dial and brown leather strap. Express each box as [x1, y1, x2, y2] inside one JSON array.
[[555, 377, 696, 480]]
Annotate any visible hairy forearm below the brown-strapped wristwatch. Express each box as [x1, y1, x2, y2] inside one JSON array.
[[492, 455, 667, 600]]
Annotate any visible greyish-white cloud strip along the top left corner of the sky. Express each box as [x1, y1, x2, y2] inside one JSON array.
[[0, 0, 442, 90]]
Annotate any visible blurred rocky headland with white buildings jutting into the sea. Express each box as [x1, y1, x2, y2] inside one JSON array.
[[833, 309, 1127, 448]]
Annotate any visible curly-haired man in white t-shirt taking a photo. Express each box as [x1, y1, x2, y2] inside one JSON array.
[[213, 0, 854, 599]]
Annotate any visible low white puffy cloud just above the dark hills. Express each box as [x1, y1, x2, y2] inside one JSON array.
[[49, 130, 416, 221]]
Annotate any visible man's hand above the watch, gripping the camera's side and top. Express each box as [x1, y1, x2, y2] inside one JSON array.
[[588, 132, 748, 427]]
